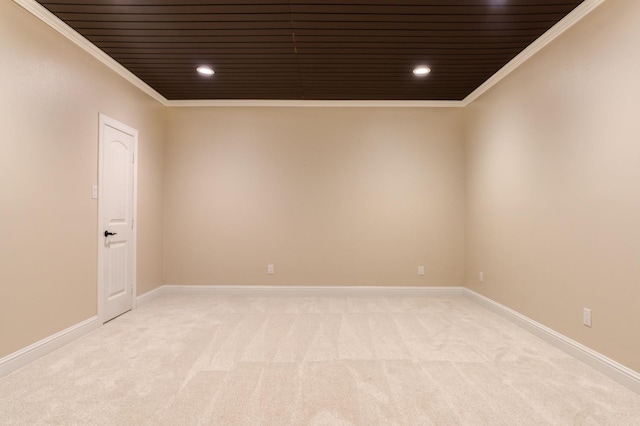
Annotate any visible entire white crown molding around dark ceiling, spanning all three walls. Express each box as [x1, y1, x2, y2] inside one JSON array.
[[13, 0, 606, 108]]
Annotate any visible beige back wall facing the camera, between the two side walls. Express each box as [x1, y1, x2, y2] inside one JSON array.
[[164, 108, 464, 286]]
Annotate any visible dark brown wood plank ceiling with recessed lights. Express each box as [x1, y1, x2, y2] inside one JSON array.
[[33, 0, 582, 100]]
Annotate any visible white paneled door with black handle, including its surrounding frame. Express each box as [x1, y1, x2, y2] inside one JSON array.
[[98, 114, 138, 323]]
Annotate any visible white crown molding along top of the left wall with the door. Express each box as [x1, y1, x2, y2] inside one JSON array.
[[13, 0, 167, 106]]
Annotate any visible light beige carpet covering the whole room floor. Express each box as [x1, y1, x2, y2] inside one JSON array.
[[0, 295, 640, 425]]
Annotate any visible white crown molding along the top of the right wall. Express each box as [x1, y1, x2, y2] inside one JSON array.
[[462, 0, 606, 107]]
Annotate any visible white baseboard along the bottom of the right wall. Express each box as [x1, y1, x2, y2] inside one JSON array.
[[463, 288, 640, 393]]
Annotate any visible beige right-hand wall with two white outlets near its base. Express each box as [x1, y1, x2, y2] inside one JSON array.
[[466, 0, 640, 371]]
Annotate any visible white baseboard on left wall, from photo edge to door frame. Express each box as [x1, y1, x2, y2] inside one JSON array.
[[0, 316, 101, 377]]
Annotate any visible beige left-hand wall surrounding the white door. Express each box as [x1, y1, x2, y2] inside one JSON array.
[[0, 1, 164, 357]]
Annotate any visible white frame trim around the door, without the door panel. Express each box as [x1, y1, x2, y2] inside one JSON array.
[[97, 113, 138, 324]]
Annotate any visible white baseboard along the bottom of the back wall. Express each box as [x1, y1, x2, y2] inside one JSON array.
[[161, 285, 464, 297]]
